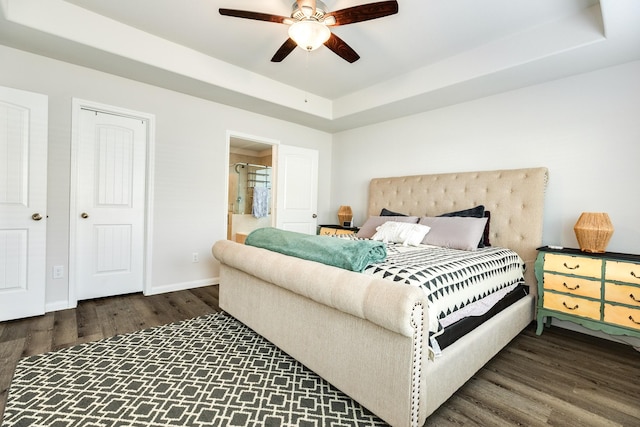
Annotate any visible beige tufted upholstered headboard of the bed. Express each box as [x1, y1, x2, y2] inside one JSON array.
[[368, 167, 548, 294]]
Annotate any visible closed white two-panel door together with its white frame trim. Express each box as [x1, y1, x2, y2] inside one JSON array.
[[69, 98, 155, 307]]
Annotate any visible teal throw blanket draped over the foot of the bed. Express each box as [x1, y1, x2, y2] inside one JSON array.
[[245, 227, 387, 272]]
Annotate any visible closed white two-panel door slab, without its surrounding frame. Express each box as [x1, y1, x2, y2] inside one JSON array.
[[72, 109, 147, 300]]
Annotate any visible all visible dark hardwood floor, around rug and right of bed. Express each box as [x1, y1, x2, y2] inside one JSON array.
[[0, 286, 640, 427]]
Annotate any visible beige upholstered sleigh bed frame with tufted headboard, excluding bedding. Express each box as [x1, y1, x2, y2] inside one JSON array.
[[212, 168, 548, 426]]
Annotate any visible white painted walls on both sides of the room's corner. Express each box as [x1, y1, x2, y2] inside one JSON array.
[[0, 40, 640, 314]]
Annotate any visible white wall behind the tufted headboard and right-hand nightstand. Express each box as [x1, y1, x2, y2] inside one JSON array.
[[331, 62, 640, 254]]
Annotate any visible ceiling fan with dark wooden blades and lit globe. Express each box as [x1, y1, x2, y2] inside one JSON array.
[[219, 0, 398, 62]]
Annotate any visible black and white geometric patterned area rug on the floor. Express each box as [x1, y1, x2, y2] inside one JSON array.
[[2, 313, 386, 427]]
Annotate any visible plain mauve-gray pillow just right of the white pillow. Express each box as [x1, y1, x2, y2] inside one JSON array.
[[419, 216, 487, 251]]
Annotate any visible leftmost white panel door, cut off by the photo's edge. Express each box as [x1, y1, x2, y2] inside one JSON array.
[[0, 87, 48, 321]]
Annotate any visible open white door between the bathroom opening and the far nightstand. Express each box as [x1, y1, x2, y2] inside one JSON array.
[[276, 145, 318, 234]]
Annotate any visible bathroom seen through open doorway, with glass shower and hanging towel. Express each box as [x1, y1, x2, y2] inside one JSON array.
[[227, 134, 276, 243]]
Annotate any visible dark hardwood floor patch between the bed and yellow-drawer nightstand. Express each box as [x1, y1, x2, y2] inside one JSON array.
[[426, 324, 640, 427]]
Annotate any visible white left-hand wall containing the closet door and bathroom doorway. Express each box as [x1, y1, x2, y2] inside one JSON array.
[[0, 46, 331, 309]]
